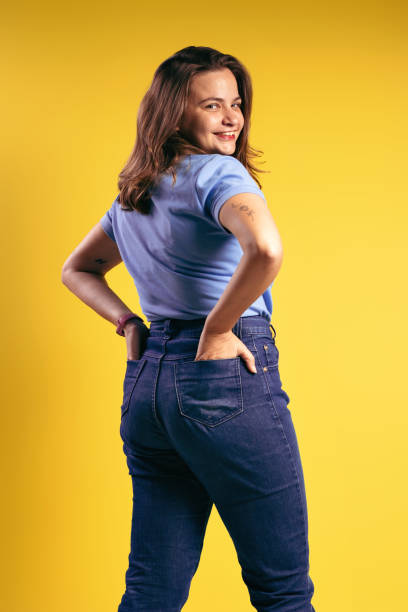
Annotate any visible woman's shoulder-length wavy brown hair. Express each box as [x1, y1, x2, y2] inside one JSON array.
[[118, 46, 267, 215]]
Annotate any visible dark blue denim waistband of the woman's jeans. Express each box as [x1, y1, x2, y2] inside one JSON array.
[[150, 315, 276, 339]]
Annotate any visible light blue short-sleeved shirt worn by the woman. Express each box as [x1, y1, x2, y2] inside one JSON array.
[[100, 153, 273, 321]]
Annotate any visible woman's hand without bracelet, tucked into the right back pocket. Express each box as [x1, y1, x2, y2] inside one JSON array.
[[194, 330, 256, 373]]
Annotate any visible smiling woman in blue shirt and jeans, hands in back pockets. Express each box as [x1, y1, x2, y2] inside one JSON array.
[[62, 47, 314, 612]]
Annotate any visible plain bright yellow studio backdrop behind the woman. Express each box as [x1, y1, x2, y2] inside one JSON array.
[[0, 0, 408, 612]]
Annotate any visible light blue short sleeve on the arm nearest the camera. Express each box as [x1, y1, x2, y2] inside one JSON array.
[[195, 154, 266, 234]]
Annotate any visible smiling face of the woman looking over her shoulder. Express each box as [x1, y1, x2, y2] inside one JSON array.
[[178, 68, 244, 155]]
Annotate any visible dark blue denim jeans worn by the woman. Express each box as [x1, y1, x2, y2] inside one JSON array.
[[118, 315, 314, 612]]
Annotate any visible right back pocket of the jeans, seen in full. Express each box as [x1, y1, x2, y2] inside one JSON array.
[[174, 357, 244, 427]]
